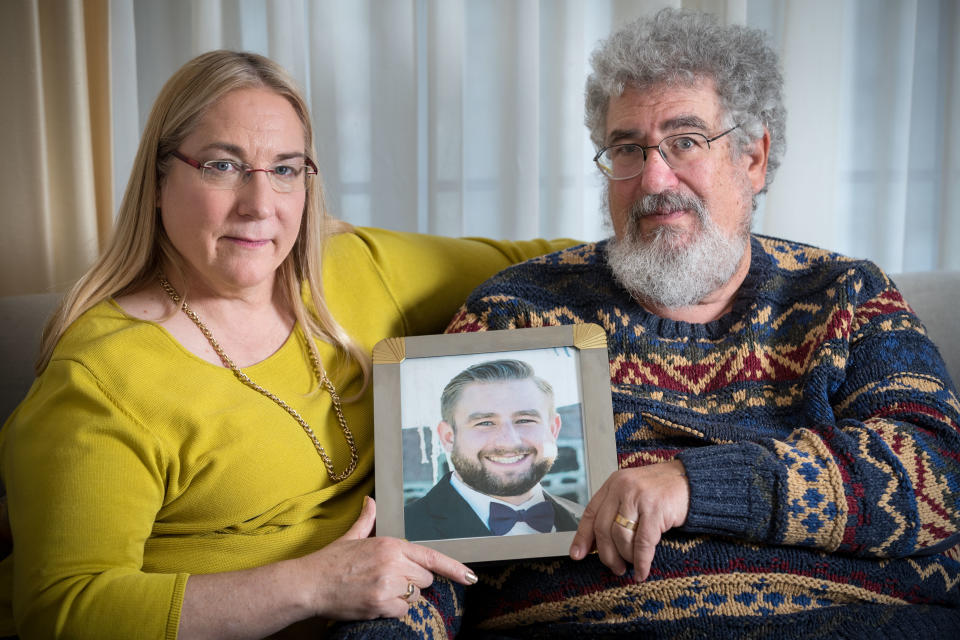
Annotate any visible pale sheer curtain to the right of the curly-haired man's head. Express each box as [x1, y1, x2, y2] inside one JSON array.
[[748, 0, 960, 272]]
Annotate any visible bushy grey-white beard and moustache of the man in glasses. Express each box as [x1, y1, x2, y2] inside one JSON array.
[[607, 192, 750, 308]]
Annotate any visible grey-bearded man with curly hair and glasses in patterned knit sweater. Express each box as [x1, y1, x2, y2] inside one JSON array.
[[440, 10, 960, 638]]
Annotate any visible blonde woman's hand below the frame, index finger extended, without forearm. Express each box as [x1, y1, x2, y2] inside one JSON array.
[[303, 498, 477, 620]]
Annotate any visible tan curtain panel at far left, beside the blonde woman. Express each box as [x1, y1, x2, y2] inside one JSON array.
[[0, 0, 113, 295]]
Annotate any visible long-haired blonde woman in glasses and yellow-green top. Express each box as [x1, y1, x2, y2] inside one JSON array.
[[0, 51, 568, 638]]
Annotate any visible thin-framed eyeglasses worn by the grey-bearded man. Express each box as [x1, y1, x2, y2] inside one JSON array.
[[593, 124, 740, 180]]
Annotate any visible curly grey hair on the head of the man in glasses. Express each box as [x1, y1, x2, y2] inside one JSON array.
[[584, 8, 787, 193]]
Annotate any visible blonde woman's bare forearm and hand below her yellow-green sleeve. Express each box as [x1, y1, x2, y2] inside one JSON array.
[[178, 498, 477, 640]]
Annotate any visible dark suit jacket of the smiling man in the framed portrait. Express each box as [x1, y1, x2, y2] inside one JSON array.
[[403, 473, 583, 542]]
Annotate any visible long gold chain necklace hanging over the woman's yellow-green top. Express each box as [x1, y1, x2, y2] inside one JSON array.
[[158, 273, 359, 482]]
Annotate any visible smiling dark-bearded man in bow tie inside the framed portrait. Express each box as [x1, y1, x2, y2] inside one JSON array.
[[404, 360, 583, 541]]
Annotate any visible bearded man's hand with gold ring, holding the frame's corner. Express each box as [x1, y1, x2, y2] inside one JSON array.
[[570, 460, 690, 582]]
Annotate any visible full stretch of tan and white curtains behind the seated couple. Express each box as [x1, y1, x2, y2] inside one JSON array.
[[0, 0, 960, 294]]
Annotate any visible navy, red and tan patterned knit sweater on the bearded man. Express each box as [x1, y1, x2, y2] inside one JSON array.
[[338, 236, 960, 639]]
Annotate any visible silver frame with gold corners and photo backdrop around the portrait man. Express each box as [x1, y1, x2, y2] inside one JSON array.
[[373, 324, 617, 562]]
